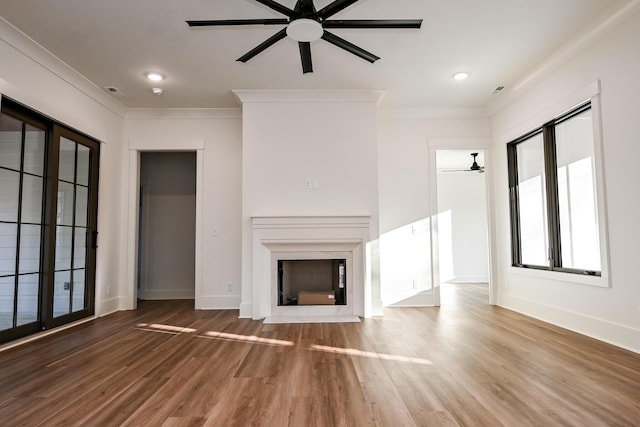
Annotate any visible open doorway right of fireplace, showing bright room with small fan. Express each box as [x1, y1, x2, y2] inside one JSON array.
[[436, 149, 490, 305]]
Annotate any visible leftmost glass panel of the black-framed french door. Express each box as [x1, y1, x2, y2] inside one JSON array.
[[0, 110, 46, 341]]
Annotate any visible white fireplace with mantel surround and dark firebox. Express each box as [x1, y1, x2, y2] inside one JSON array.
[[248, 216, 370, 323]]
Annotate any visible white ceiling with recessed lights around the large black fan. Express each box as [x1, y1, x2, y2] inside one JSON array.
[[0, 0, 635, 109]]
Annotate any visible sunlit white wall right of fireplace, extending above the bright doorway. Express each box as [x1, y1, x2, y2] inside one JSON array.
[[378, 115, 491, 306]]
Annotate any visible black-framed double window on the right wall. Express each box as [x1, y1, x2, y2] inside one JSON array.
[[507, 102, 602, 276]]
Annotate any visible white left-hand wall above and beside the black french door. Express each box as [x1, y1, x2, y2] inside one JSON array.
[[0, 18, 124, 315]]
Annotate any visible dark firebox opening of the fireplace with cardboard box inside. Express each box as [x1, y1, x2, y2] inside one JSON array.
[[278, 259, 347, 306]]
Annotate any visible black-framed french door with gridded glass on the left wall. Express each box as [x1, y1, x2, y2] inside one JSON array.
[[0, 98, 100, 342]]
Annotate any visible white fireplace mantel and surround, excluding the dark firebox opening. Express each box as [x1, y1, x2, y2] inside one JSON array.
[[251, 216, 371, 321]]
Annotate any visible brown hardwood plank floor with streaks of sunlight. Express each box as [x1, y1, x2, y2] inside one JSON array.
[[0, 285, 640, 426]]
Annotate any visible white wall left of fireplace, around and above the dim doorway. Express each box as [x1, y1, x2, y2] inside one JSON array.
[[123, 109, 242, 309]]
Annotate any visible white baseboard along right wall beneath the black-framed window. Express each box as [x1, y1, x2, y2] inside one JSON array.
[[499, 292, 640, 353]]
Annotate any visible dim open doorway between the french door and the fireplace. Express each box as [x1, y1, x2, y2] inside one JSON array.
[[137, 151, 196, 300]]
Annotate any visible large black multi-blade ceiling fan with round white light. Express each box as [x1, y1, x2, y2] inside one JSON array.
[[186, 0, 422, 74]]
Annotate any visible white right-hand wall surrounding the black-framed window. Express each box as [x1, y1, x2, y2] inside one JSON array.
[[492, 8, 640, 352]]
